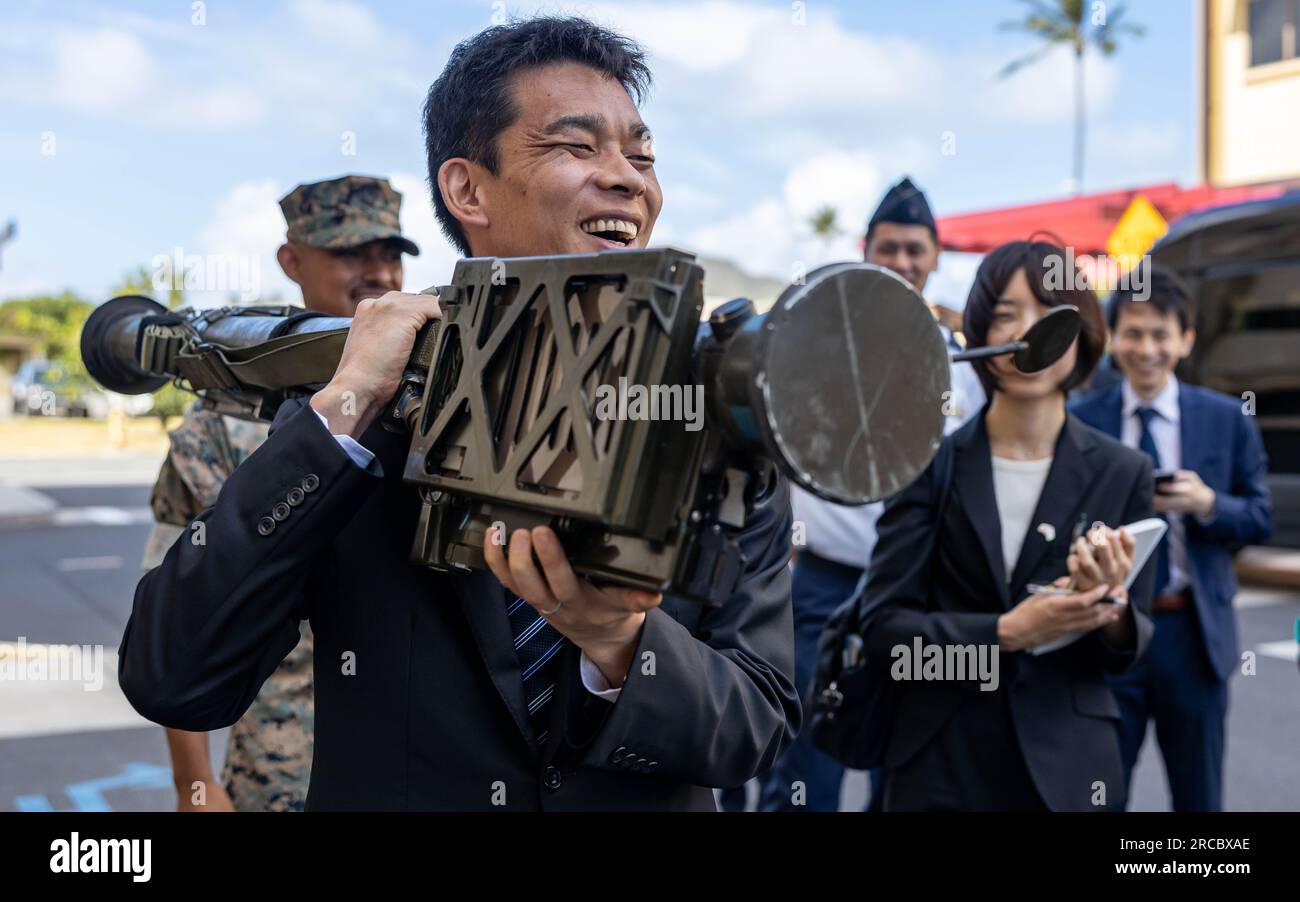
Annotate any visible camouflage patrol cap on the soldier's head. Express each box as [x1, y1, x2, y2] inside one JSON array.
[[280, 175, 420, 256]]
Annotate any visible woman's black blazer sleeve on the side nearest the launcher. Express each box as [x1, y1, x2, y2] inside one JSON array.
[[859, 452, 1000, 670]]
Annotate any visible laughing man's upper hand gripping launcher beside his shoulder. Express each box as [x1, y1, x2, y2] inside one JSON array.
[[311, 291, 442, 438]]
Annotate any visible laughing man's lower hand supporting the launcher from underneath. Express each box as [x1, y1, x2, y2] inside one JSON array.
[[484, 526, 663, 688]]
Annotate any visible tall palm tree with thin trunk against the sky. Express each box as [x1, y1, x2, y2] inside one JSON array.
[[998, 0, 1145, 194]]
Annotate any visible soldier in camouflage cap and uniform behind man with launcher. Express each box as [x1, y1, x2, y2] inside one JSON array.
[[144, 175, 420, 811]]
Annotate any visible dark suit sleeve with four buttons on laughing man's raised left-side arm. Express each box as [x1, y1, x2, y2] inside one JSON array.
[[118, 402, 382, 730]]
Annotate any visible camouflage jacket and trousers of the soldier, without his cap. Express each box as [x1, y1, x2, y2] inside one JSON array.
[[144, 403, 316, 811]]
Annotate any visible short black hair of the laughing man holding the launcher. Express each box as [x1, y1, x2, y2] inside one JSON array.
[[424, 16, 651, 256]]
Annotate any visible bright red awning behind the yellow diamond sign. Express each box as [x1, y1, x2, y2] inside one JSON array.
[[939, 182, 1295, 255]]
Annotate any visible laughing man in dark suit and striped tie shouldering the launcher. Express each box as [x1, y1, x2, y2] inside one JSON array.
[[120, 18, 800, 810]]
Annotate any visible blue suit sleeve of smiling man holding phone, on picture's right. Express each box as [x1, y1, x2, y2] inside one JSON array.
[[1187, 408, 1273, 548]]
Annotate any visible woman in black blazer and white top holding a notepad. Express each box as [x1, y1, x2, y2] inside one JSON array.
[[862, 242, 1153, 811]]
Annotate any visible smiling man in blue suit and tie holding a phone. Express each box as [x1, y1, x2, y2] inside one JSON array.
[[1071, 266, 1273, 811]]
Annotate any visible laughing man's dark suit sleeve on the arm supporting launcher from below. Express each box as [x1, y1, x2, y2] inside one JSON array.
[[582, 478, 802, 786]]
